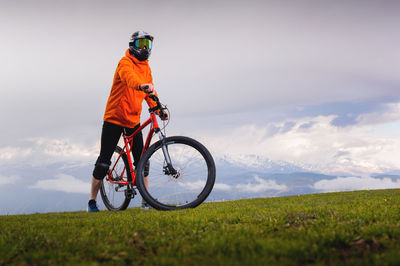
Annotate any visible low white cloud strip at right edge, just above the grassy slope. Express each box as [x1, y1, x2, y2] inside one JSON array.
[[313, 177, 400, 192]]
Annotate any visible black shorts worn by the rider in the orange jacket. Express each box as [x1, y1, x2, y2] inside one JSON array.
[[96, 121, 143, 167]]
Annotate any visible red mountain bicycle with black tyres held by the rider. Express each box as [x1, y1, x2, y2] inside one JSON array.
[[100, 96, 216, 211]]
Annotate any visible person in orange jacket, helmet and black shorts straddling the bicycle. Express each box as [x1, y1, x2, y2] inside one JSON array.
[[88, 31, 168, 212]]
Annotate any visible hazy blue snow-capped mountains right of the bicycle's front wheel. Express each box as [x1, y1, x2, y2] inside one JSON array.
[[210, 155, 335, 200]]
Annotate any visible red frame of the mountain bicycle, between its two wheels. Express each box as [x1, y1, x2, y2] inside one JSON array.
[[106, 112, 161, 185]]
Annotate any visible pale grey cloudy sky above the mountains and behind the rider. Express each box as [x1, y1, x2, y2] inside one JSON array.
[[0, 0, 400, 185]]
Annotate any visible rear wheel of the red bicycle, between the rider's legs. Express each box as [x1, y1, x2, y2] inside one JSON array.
[[100, 146, 135, 211]]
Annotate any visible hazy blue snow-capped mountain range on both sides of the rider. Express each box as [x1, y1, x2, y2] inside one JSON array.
[[0, 155, 400, 215]]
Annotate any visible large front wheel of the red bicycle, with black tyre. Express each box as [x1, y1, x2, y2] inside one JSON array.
[[136, 136, 216, 210]]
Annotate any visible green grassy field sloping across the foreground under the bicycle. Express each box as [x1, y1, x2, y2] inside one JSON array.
[[0, 189, 400, 265]]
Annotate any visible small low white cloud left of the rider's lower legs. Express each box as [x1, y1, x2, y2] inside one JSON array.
[[29, 174, 90, 194]]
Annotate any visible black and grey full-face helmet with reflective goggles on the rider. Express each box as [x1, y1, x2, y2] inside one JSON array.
[[129, 30, 154, 61]]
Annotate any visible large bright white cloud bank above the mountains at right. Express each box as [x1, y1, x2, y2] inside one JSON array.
[[200, 105, 400, 175]]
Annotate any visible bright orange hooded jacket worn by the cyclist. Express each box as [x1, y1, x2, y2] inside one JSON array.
[[104, 49, 156, 128]]
